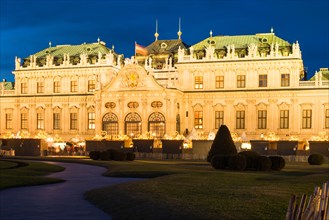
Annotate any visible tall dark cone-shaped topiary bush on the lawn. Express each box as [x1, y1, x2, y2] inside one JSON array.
[[207, 125, 237, 162]]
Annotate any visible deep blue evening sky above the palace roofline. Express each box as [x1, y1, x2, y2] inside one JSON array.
[[0, 0, 329, 81]]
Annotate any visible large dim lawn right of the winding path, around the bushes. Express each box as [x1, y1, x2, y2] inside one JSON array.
[[85, 161, 329, 219]]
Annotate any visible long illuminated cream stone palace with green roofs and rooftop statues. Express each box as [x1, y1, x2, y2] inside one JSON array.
[[0, 27, 329, 143]]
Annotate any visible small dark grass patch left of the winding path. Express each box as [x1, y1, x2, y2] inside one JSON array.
[[0, 160, 64, 190]]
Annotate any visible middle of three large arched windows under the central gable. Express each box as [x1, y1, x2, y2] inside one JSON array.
[[125, 112, 142, 138]]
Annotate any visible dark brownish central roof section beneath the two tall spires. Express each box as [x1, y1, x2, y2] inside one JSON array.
[[146, 39, 189, 54]]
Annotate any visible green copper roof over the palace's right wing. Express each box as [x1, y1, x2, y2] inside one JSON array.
[[192, 33, 291, 50]]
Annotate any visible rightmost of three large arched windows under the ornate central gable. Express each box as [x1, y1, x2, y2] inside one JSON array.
[[148, 112, 166, 138]]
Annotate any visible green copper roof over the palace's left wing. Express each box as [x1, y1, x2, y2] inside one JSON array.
[[34, 43, 110, 58]]
